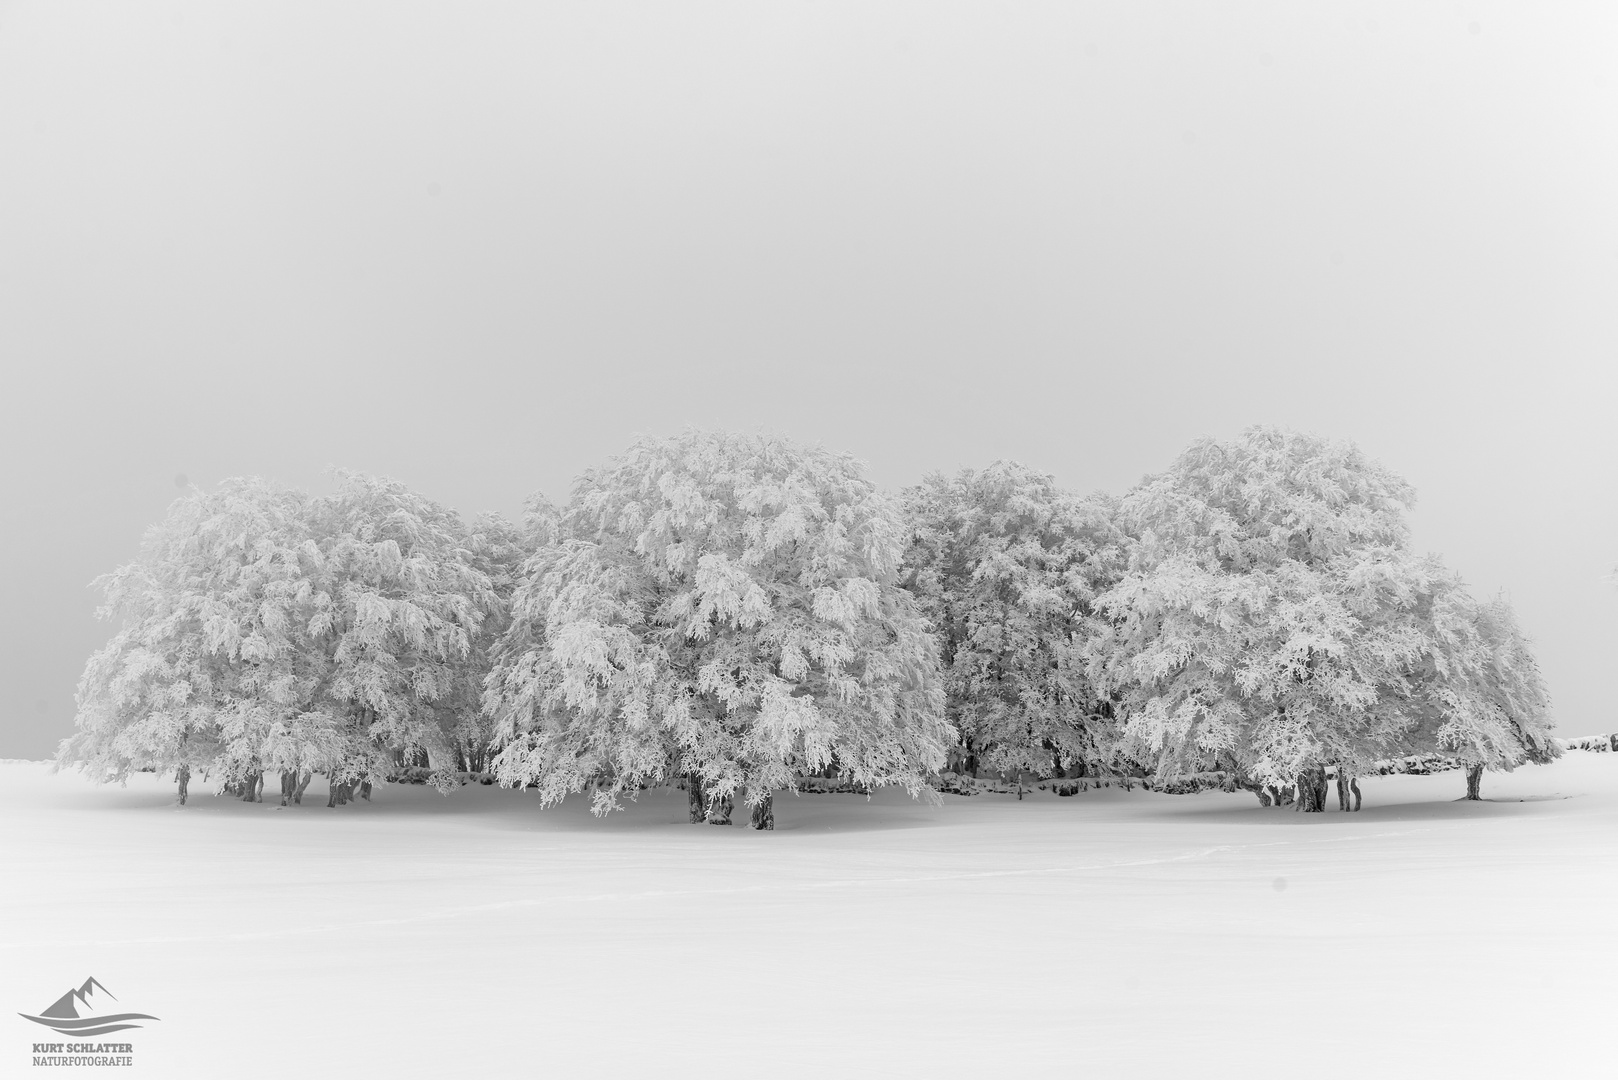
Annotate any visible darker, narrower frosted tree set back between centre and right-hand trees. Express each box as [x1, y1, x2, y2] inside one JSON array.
[[904, 461, 1125, 776]]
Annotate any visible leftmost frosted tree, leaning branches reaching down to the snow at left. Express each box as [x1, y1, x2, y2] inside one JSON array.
[[57, 479, 319, 803]]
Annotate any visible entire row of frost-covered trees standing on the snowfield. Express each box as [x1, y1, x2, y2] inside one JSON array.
[[58, 427, 1557, 829]]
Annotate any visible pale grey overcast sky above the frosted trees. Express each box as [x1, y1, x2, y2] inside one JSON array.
[[0, 0, 1618, 756]]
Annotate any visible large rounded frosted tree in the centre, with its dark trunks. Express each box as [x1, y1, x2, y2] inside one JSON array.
[[485, 432, 953, 829]]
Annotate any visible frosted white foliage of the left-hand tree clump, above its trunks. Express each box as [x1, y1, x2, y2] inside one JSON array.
[[58, 473, 504, 779]]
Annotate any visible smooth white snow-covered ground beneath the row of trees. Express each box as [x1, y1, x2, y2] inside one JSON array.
[[0, 753, 1618, 1078]]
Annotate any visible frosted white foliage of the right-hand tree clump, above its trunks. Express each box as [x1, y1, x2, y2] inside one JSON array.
[[1089, 429, 1548, 784]]
